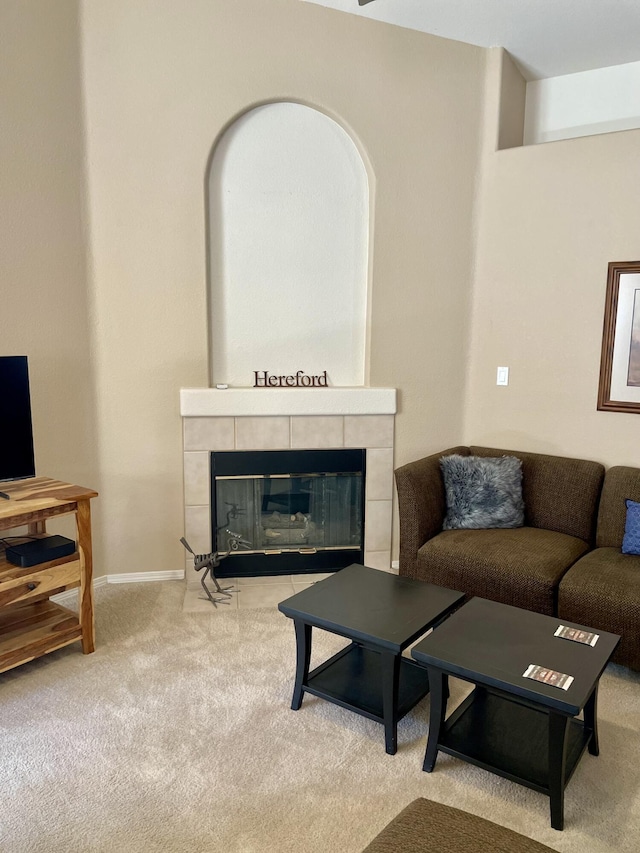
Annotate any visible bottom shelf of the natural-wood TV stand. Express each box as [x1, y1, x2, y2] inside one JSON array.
[[0, 600, 82, 672]]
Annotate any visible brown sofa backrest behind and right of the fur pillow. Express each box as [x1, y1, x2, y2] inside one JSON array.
[[469, 446, 604, 543]]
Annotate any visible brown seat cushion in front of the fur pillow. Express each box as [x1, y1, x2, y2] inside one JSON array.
[[417, 527, 588, 621]]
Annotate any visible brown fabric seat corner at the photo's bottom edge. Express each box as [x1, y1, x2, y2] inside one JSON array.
[[363, 798, 551, 853]]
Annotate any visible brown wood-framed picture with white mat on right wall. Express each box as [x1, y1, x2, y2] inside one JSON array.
[[598, 261, 640, 414]]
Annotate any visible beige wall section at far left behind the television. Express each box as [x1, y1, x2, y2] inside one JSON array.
[[0, 0, 98, 496]]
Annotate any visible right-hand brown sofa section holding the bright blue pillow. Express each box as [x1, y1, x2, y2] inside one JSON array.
[[558, 466, 640, 670]]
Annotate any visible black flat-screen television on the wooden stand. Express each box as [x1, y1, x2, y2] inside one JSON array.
[[0, 355, 36, 480]]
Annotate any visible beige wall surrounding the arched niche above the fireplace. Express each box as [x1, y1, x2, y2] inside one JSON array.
[[82, 0, 484, 573]]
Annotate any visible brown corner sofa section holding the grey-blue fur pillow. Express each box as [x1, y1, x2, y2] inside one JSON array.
[[395, 446, 604, 616]]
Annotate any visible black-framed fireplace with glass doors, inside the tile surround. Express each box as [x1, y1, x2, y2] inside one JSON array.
[[211, 449, 366, 577]]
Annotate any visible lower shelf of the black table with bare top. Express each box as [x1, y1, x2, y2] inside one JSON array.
[[304, 643, 429, 722]]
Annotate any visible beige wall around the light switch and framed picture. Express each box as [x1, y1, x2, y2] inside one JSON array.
[[465, 72, 640, 465]]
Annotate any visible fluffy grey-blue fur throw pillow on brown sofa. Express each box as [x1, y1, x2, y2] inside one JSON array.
[[440, 453, 524, 530]]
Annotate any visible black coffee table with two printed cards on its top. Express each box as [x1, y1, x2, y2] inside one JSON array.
[[411, 598, 620, 829]]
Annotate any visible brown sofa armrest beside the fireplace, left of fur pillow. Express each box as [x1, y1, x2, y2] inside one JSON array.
[[395, 447, 469, 578]]
